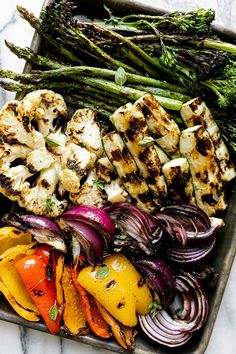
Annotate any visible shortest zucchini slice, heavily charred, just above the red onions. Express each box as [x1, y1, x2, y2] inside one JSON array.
[[162, 157, 195, 204]]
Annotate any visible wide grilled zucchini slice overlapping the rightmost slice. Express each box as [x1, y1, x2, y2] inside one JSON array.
[[180, 125, 227, 215]]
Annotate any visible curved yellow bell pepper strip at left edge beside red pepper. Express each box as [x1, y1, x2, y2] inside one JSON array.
[[0, 242, 40, 322]]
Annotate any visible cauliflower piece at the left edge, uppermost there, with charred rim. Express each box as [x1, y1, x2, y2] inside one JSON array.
[[0, 101, 45, 149]]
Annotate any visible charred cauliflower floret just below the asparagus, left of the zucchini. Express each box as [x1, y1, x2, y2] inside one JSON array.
[[65, 108, 103, 157]]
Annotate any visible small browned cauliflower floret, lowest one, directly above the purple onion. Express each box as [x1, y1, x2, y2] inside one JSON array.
[[70, 170, 104, 208]]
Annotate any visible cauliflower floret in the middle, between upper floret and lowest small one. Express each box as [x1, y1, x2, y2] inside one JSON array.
[[60, 142, 96, 193]]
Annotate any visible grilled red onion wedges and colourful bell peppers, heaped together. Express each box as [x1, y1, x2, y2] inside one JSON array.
[[0, 203, 223, 349]]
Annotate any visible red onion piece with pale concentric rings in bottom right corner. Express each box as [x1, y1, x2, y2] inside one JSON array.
[[139, 271, 208, 347]]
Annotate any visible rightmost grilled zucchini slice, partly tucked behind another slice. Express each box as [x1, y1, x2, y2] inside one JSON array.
[[180, 97, 236, 182]]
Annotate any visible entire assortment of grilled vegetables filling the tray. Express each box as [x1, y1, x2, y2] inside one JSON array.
[[0, 0, 236, 350]]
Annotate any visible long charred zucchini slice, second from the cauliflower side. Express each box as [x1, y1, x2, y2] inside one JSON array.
[[111, 101, 167, 205]]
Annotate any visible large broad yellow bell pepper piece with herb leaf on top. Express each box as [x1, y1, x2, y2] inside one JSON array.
[[77, 254, 152, 327]]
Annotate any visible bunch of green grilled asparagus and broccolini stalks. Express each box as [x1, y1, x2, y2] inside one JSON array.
[[0, 0, 236, 151]]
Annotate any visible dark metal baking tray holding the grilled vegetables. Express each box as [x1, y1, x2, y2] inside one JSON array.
[[0, 0, 236, 354]]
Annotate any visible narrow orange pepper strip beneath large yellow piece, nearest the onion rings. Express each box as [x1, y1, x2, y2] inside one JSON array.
[[95, 300, 138, 350]]
